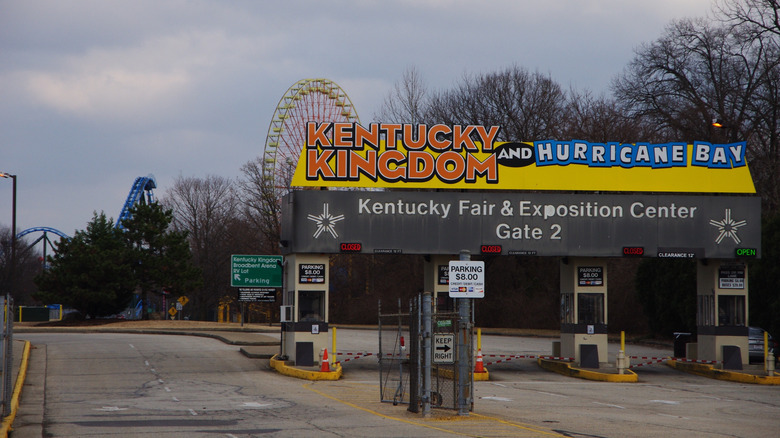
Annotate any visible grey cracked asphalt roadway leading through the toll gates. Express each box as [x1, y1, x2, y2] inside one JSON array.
[[11, 330, 780, 438]]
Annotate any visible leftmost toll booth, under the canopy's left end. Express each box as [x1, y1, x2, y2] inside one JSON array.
[[281, 254, 330, 366]]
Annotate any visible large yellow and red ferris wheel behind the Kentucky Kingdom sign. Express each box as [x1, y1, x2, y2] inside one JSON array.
[[262, 79, 360, 191]]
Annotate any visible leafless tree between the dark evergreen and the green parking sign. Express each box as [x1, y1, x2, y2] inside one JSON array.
[[161, 175, 239, 319]]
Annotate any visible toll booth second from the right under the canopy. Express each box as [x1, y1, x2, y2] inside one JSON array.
[[553, 257, 608, 368]]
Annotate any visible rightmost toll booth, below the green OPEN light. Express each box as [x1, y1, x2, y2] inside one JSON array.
[[695, 259, 748, 369]]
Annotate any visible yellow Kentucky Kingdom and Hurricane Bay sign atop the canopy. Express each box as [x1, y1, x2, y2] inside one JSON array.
[[291, 122, 755, 193]]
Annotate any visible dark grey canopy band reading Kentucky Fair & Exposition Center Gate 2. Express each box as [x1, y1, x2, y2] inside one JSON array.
[[281, 190, 761, 259]]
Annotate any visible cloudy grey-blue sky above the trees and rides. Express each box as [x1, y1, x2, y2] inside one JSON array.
[[0, 0, 712, 243]]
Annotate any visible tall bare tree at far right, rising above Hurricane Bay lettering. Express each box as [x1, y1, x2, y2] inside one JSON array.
[[613, 19, 780, 211]]
